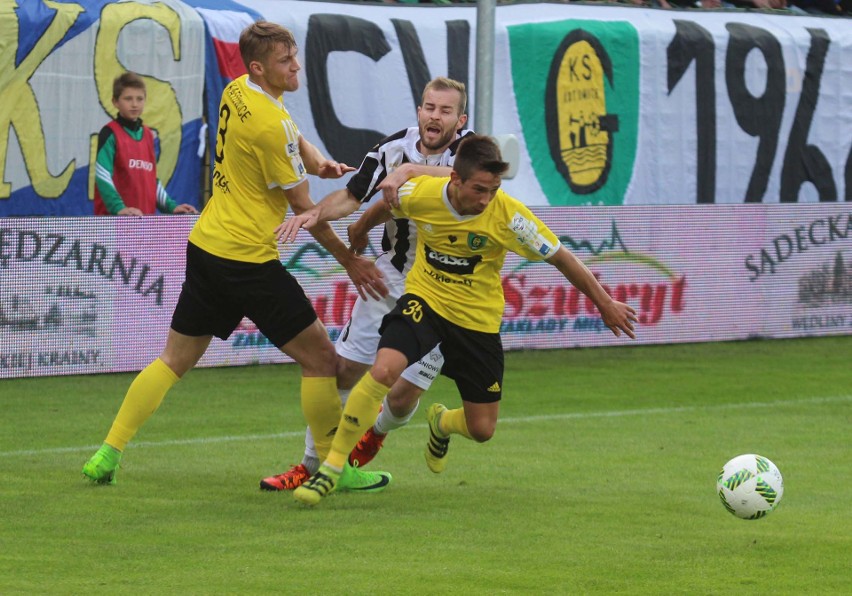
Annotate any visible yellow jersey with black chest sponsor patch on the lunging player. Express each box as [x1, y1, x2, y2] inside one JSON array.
[[393, 176, 560, 333]]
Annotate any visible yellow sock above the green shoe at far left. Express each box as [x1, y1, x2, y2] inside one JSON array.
[[104, 358, 180, 451]]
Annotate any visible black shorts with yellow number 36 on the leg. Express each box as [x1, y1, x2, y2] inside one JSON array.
[[379, 294, 504, 404]]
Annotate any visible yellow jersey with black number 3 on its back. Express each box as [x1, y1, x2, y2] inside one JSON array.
[[189, 75, 307, 263]]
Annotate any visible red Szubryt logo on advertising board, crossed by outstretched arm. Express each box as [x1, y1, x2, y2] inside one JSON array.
[[501, 221, 687, 334]]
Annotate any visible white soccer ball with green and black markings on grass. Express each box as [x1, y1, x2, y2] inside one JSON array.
[[716, 453, 784, 519]]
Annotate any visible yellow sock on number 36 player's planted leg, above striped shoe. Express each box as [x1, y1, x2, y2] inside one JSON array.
[[326, 373, 390, 469]]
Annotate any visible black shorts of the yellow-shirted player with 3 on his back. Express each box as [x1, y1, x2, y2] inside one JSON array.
[[172, 243, 317, 348]]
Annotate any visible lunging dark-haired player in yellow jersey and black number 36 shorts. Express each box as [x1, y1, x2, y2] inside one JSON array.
[[293, 135, 637, 505]]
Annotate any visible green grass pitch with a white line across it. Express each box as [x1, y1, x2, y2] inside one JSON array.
[[0, 337, 852, 595]]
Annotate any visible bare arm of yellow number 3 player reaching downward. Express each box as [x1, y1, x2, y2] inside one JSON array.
[[282, 180, 388, 300]]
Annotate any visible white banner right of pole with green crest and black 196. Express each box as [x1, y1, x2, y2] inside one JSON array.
[[494, 5, 852, 205]]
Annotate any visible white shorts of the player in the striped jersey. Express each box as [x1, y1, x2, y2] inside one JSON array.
[[335, 254, 444, 391]]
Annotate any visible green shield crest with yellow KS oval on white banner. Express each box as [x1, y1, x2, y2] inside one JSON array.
[[508, 20, 639, 205]]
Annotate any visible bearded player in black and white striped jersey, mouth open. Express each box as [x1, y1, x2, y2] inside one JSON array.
[[260, 77, 472, 490]]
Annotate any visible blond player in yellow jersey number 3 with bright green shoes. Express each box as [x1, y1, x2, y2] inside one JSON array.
[[83, 22, 390, 490]]
